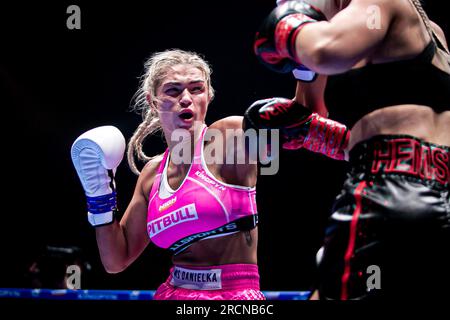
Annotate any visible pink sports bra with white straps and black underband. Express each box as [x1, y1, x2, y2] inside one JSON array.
[[147, 126, 258, 254]]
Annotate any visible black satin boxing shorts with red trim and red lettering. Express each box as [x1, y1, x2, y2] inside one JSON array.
[[318, 135, 450, 299]]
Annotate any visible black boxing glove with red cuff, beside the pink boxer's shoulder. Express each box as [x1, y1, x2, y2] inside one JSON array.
[[244, 98, 350, 160]]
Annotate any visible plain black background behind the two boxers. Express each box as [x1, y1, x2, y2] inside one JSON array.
[[0, 0, 449, 290]]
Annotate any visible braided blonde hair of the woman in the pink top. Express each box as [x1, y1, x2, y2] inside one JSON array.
[[127, 49, 214, 175]]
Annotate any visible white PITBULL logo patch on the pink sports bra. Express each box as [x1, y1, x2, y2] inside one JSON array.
[[147, 203, 198, 237]]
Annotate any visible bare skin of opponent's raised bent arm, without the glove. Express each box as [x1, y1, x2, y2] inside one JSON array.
[[295, 0, 395, 74]]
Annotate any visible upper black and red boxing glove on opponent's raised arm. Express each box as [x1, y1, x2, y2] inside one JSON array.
[[254, 0, 326, 73]]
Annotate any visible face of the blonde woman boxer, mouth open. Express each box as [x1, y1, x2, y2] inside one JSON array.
[[156, 64, 210, 137]]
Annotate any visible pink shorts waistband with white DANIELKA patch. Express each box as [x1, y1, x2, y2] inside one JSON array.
[[169, 264, 259, 290]]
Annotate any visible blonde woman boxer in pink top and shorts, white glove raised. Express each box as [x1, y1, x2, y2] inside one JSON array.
[[72, 50, 264, 300]]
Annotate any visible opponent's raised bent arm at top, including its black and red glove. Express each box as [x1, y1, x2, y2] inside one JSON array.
[[255, 0, 395, 74]]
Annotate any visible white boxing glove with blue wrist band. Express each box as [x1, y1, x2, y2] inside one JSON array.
[[71, 126, 125, 226]]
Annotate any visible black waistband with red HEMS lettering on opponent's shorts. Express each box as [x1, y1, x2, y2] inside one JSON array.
[[349, 135, 450, 188]]
